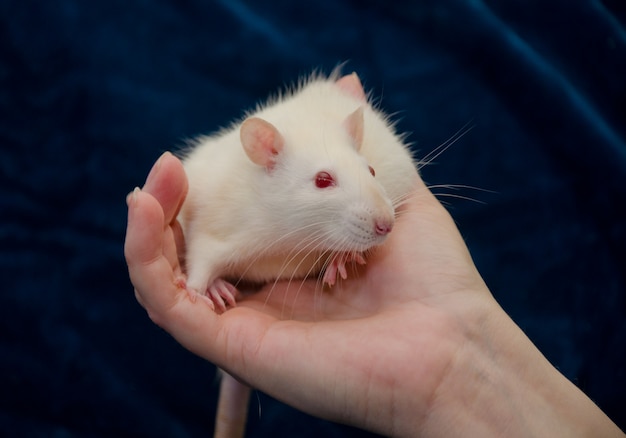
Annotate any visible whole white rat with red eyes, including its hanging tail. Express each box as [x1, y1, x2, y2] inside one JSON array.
[[179, 71, 417, 436]]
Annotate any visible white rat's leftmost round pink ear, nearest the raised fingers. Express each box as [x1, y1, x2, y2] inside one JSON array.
[[239, 117, 284, 170]]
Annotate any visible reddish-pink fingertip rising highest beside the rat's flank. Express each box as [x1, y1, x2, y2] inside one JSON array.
[[143, 152, 188, 224]]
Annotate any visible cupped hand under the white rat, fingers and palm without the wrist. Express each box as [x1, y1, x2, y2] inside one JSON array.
[[125, 154, 496, 431]]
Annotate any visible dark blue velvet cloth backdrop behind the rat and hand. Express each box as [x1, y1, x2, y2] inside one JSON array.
[[0, 0, 626, 437]]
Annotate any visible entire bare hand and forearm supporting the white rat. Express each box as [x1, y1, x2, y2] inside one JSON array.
[[125, 153, 624, 437]]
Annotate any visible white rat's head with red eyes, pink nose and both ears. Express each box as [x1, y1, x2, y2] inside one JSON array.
[[240, 102, 394, 251]]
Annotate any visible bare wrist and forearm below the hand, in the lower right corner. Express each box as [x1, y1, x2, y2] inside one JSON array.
[[414, 302, 624, 437]]
